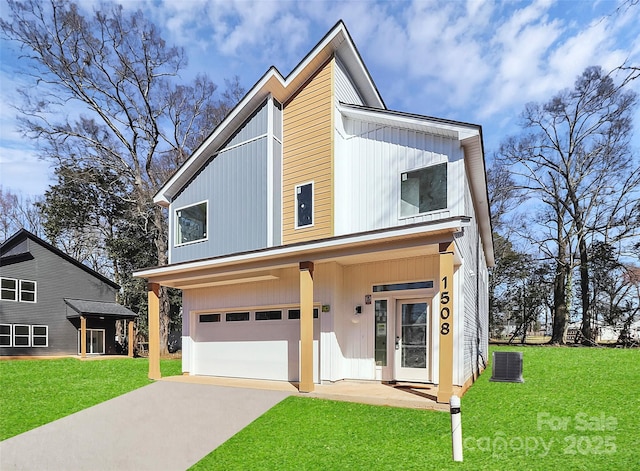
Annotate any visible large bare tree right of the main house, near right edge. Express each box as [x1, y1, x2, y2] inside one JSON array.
[[500, 67, 640, 342]]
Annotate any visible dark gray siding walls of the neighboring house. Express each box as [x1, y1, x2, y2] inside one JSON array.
[[0, 240, 116, 355]]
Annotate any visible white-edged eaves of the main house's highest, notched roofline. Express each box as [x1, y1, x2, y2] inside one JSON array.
[[153, 21, 385, 206]]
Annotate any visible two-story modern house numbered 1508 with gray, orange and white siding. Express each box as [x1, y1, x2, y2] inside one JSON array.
[[136, 22, 493, 401]]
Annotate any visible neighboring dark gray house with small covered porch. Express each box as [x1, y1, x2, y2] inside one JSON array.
[[0, 229, 137, 356]]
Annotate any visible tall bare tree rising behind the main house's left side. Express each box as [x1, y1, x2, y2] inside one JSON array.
[[0, 0, 242, 353]]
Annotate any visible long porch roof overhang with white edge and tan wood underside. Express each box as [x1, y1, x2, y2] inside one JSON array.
[[135, 220, 464, 290]]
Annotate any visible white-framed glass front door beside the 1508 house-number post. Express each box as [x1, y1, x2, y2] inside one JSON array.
[[394, 299, 430, 382]]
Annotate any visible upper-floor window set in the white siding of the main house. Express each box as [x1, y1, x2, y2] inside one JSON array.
[[400, 163, 447, 216]]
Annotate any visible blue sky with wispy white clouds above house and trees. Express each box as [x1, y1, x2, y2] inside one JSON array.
[[0, 0, 640, 195]]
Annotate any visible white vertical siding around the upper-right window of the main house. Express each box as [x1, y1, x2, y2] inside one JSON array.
[[335, 116, 465, 235]]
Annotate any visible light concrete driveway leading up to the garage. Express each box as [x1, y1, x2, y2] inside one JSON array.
[[0, 381, 291, 471]]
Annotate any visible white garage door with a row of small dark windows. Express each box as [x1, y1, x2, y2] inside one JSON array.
[[192, 308, 320, 382]]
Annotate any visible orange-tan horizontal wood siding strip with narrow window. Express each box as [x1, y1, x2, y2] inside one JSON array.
[[282, 59, 334, 244]]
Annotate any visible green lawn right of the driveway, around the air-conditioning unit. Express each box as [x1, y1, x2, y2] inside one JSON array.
[[192, 346, 640, 470]]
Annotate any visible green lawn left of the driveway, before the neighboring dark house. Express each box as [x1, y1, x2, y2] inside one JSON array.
[[0, 358, 181, 440]]
